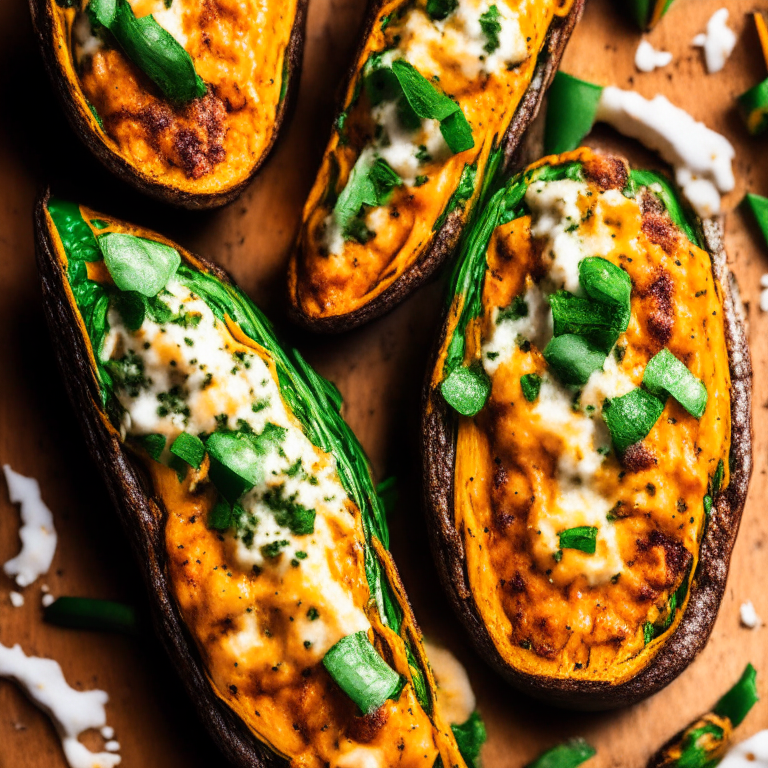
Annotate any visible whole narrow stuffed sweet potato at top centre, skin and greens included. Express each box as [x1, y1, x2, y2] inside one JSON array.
[[288, 0, 583, 331]]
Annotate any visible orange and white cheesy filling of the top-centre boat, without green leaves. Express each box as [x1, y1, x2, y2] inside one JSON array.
[[289, 0, 570, 317]]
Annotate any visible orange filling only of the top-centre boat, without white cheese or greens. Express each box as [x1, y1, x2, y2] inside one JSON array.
[[289, 0, 570, 317]]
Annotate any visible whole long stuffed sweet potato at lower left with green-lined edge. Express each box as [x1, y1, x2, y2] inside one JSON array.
[[36, 198, 482, 768]]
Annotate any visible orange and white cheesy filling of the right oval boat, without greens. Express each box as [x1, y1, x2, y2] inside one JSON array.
[[435, 153, 730, 682]]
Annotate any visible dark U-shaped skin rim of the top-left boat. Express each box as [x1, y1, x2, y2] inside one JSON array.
[[29, 0, 309, 210]]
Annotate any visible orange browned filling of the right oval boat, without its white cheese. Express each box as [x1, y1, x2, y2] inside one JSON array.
[[436, 151, 730, 682]]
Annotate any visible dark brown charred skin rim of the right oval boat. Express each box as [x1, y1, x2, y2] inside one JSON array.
[[421, 196, 752, 711]]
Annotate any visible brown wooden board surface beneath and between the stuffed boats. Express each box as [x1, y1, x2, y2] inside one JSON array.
[[0, 0, 768, 768]]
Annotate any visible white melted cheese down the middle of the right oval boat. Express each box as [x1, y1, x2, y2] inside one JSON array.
[[482, 179, 637, 585]]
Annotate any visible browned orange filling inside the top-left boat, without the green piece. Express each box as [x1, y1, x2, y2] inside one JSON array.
[[54, 0, 297, 193]]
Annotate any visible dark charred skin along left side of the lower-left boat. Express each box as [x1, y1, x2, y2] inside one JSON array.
[[34, 191, 288, 768]]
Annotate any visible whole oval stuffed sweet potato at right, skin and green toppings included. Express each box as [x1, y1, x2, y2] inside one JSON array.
[[422, 149, 752, 708]]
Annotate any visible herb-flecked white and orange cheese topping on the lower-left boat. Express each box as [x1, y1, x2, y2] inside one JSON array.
[[100, 279, 438, 768]]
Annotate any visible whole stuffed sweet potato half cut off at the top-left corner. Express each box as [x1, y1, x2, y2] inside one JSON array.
[[30, 0, 307, 208]]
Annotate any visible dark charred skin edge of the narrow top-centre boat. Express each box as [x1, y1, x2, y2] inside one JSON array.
[[288, 0, 586, 333]]
